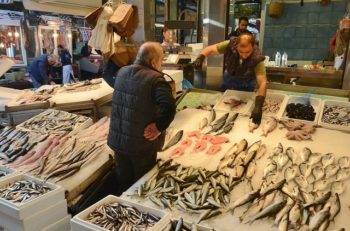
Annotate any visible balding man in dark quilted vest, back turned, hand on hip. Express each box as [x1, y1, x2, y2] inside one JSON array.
[[108, 42, 175, 194]]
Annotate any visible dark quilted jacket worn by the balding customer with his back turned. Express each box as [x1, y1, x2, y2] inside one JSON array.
[[108, 64, 176, 153]]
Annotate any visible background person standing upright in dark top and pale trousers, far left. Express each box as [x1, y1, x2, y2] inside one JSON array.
[[57, 45, 75, 84]]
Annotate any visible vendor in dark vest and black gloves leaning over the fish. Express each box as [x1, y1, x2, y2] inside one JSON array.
[[193, 33, 267, 124]]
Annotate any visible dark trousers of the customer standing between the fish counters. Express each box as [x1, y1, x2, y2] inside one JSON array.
[[114, 151, 157, 196]]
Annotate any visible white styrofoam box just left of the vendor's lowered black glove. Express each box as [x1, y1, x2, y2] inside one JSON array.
[[214, 90, 255, 115]]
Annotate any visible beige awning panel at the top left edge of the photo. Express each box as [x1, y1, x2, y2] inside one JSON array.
[[23, 0, 102, 16]]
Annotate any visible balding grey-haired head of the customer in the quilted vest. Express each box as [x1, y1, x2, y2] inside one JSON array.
[[135, 42, 163, 65]]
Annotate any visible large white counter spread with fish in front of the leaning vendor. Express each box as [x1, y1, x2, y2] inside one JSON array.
[[118, 87, 350, 230]]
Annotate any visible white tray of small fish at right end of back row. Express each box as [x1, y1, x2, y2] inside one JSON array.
[[318, 100, 350, 132]]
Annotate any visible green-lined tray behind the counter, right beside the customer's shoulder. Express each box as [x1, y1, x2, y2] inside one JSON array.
[[176, 88, 222, 110]]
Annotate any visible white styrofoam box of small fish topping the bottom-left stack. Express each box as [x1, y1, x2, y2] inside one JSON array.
[[0, 174, 65, 220]]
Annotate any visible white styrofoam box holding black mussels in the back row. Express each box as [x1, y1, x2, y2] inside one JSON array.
[[281, 96, 322, 124]]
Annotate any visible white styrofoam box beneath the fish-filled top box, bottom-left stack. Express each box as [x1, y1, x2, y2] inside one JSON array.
[[0, 200, 67, 231]]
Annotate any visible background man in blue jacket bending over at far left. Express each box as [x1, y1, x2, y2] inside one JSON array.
[[28, 54, 57, 88]]
